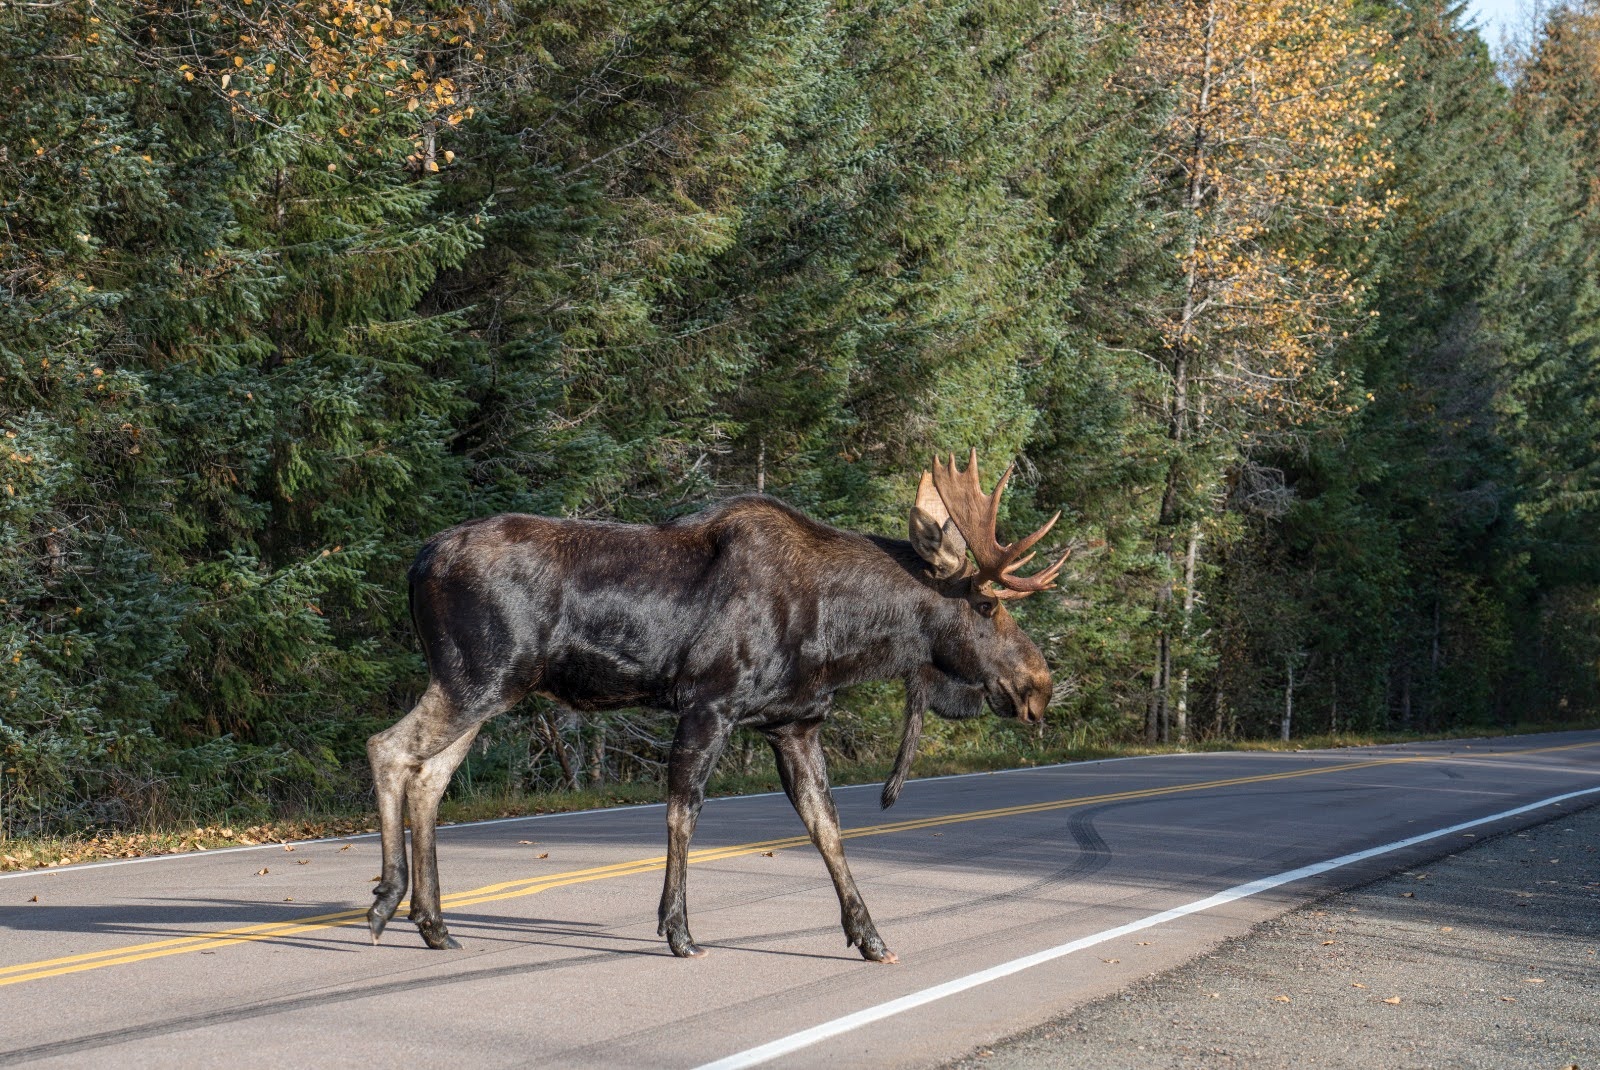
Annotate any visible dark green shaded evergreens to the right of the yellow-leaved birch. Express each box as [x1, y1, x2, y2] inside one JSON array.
[[1219, 2, 1600, 731]]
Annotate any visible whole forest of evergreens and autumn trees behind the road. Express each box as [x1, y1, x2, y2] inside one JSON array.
[[0, 0, 1600, 838]]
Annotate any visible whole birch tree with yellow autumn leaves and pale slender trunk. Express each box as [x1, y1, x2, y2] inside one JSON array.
[[1136, 0, 1397, 741]]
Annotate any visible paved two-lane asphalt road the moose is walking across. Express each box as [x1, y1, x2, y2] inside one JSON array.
[[0, 733, 1600, 1067]]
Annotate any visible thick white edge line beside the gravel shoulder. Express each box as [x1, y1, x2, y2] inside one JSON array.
[[696, 787, 1600, 1070]]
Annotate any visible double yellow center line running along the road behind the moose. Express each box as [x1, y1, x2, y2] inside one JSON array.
[[0, 742, 1600, 987]]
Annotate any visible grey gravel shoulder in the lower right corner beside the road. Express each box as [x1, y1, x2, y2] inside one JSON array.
[[950, 806, 1600, 1070]]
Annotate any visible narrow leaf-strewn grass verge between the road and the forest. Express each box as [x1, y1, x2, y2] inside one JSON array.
[[0, 721, 1600, 872]]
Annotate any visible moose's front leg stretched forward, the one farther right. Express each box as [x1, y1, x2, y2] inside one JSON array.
[[766, 721, 899, 963]]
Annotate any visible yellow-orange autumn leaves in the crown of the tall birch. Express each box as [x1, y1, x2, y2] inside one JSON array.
[[1139, 0, 1398, 422]]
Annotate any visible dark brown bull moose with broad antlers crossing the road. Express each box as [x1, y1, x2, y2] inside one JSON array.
[[366, 449, 1066, 963]]
